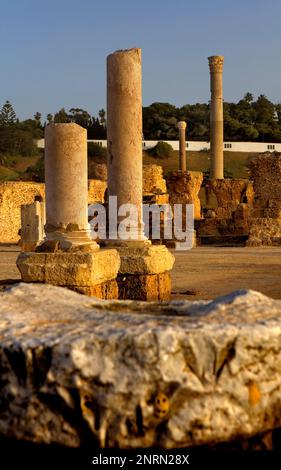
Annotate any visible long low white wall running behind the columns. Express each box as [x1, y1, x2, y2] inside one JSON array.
[[37, 139, 281, 153]]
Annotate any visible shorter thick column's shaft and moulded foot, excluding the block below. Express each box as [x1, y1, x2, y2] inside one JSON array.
[[45, 123, 98, 246]]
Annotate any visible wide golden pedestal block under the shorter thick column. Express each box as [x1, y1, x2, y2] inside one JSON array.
[[17, 249, 120, 287]]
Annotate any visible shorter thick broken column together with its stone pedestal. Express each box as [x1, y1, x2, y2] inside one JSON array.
[[17, 124, 120, 298]]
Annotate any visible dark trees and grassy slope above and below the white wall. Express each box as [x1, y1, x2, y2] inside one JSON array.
[[0, 93, 281, 181]]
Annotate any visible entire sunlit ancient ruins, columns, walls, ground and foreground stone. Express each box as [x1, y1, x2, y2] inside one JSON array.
[[0, 48, 281, 450]]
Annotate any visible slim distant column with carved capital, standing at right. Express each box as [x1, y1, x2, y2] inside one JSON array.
[[208, 56, 224, 179]]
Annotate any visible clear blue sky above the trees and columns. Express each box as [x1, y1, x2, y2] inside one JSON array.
[[0, 0, 281, 119]]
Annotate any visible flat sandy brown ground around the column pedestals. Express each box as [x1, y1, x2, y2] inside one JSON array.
[[0, 245, 281, 300]]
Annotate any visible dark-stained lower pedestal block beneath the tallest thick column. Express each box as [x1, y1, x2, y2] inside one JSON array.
[[117, 272, 171, 302]]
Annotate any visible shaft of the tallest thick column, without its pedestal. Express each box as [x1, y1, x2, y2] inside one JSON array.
[[107, 49, 144, 240]]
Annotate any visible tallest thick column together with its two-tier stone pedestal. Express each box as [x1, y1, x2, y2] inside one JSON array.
[[107, 49, 174, 300]]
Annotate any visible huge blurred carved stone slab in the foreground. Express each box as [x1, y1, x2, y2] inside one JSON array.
[[0, 283, 281, 448]]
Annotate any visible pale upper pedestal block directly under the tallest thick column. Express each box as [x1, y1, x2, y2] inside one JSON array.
[[115, 245, 175, 274]]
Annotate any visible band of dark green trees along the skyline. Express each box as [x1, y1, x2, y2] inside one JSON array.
[[0, 92, 281, 155]]
